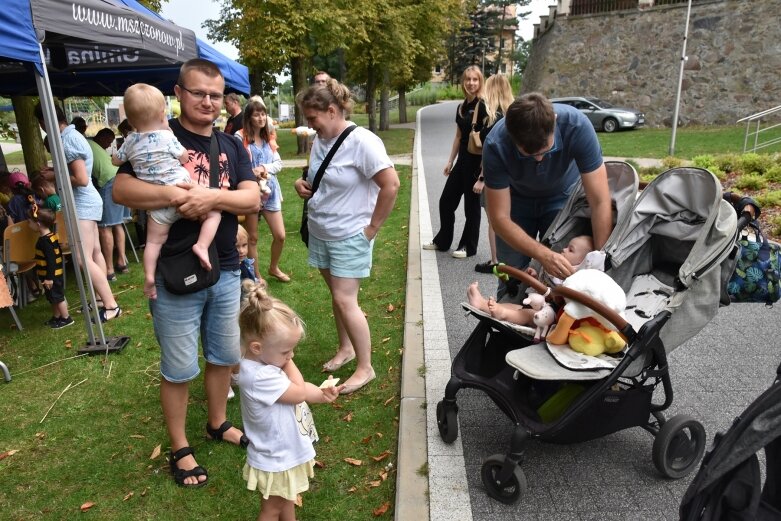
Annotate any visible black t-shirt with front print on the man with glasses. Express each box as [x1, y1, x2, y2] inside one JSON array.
[[118, 119, 255, 270]]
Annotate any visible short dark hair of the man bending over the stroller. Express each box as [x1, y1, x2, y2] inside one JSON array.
[[504, 92, 556, 154]]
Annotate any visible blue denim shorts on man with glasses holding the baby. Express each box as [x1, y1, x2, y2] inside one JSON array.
[[149, 270, 241, 383]]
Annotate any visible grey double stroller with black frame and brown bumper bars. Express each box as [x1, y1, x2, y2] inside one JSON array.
[[436, 162, 738, 503]]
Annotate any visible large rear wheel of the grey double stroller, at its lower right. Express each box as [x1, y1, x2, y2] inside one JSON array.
[[652, 414, 705, 479]]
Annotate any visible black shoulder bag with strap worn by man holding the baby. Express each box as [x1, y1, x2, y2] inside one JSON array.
[[157, 132, 220, 295]]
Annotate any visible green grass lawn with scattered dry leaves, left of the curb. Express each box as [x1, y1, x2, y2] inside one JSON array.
[[0, 162, 411, 521]]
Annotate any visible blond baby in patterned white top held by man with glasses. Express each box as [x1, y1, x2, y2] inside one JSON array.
[[114, 83, 220, 299]]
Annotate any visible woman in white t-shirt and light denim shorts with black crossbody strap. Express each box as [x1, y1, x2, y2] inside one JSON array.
[[295, 79, 399, 394]]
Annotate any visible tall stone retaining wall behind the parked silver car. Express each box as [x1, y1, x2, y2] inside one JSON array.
[[522, 0, 781, 127]]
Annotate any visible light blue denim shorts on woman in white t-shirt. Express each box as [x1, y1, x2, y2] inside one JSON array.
[[309, 230, 374, 279]]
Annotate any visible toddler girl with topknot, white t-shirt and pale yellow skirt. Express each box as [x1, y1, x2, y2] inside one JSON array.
[[239, 281, 343, 521]]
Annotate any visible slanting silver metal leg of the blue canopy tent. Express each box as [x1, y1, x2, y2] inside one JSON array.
[[35, 42, 107, 345]]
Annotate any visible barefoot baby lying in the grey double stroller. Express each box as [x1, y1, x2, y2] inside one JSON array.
[[466, 235, 594, 326]]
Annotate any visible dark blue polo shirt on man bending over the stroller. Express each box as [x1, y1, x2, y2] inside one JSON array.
[[483, 103, 603, 198]]
